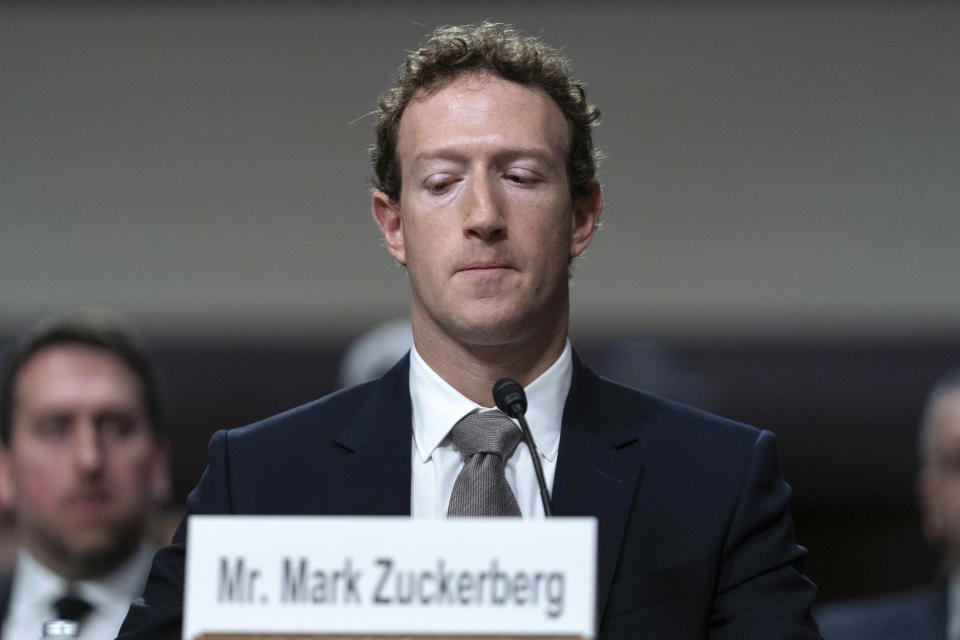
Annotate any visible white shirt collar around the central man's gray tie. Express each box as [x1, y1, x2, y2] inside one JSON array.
[[410, 340, 573, 462]]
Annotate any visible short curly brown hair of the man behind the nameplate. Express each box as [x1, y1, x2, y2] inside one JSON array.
[[370, 21, 600, 202]]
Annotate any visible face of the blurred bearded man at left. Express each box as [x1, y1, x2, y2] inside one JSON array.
[[3, 344, 169, 578]]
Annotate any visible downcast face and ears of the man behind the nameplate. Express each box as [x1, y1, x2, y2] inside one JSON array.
[[374, 73, 602, 346]]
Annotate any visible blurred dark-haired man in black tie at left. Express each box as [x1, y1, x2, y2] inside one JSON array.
[[0, 311, 170, 640]]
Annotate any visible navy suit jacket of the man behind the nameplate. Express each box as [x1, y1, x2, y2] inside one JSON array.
[[121, 356, 820, 640]]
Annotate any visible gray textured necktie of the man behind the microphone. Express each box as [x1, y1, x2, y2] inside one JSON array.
[[447, 410, 522, 516]]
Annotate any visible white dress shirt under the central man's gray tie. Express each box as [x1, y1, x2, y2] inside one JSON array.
[[410, 340, 573, 518]]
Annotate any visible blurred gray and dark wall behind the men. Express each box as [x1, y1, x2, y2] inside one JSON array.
[[0, 1, 960, 599]]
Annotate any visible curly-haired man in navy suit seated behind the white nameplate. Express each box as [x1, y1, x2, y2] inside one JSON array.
[[114, 23, 819, 640]]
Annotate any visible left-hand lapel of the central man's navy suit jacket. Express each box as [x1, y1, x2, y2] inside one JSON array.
[[326, 356, 412, 515]]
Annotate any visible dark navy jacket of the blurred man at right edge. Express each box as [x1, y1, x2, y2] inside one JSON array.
[[816, 584, 947, 640]]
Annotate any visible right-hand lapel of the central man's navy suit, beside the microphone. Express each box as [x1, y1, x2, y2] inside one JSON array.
[[551, 354, 642, 621]]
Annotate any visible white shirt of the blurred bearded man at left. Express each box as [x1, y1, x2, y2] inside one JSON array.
[[3, 545, 154, 640]]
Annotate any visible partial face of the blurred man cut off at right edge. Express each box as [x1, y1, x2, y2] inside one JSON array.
[[920, 390, 960, 566]]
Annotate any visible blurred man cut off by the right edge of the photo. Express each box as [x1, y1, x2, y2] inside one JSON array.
[[816, 369, 960, 640]]
